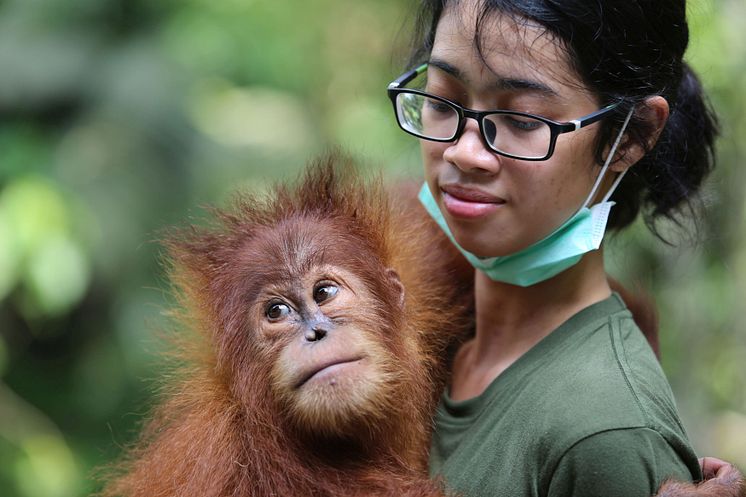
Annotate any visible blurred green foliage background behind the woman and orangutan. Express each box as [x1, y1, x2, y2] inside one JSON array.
[[0, 0, 746, 497]]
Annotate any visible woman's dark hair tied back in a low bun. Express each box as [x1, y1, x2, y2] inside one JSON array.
[[410, 0, 718, 236]]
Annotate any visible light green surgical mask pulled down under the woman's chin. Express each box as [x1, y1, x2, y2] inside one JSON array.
[[419, 110, 633, 287]]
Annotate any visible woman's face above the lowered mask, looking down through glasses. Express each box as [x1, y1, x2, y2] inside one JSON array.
[[422, 1, 600, 257]]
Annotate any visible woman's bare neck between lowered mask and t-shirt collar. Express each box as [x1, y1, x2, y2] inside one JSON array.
[[451, 250, 611, 400]]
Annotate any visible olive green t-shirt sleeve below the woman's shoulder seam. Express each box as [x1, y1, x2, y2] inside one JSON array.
[[548, 428, 692, 497]]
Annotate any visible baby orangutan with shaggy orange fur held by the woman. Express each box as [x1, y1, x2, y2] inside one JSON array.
[[103, 152, 735, 497]]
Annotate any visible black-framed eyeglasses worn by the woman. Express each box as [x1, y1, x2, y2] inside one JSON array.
[[388, 63, 619, 161]]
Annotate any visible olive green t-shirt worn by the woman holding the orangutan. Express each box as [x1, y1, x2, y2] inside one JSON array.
[[430, 294, 701, 497]]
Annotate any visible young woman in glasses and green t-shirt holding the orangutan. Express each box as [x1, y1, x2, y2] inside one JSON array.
[[389, 0, 716, 497]]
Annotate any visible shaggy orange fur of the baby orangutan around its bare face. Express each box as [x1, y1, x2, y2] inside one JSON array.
[[102, 153, 471, 497]]
